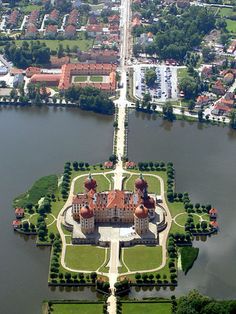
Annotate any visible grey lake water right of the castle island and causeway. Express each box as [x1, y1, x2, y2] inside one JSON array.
[[128, 113, 236, 298]]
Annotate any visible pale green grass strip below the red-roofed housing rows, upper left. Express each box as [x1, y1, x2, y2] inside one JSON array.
[[15, 38, 93, 51]]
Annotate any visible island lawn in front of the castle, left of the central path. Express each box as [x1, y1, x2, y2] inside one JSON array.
[[65, 245, 105, 271]]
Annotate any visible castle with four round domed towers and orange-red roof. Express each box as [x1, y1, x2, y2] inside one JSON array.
[[72, 175, 155, 234]]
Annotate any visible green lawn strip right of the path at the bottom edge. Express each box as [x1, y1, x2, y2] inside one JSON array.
[[122, 302, 172, 314]]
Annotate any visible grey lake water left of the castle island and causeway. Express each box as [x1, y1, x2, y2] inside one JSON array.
[[0, 107, 113, 314]]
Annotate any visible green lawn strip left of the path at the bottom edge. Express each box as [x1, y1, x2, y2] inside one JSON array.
[[52, 304, 103, 314]]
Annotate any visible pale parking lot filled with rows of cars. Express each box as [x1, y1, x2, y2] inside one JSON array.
[[134, 65, 178, 102]]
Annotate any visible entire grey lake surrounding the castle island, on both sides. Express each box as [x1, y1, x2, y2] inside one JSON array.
[[0, 108, 236, 314]]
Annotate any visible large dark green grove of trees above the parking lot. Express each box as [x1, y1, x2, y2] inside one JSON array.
[[133, 6, 216, 60]]
